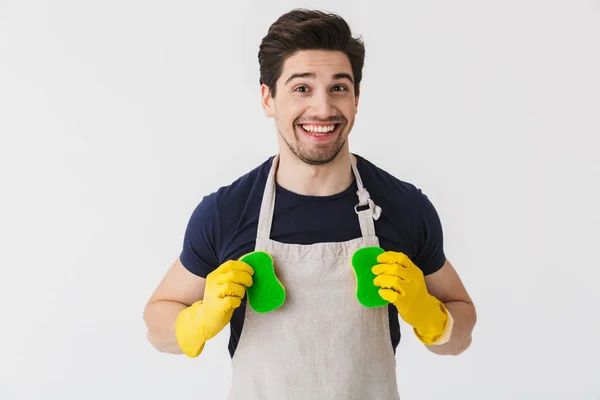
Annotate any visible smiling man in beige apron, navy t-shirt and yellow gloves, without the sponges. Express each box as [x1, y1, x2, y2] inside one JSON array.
[[144, 10, 476, 400]]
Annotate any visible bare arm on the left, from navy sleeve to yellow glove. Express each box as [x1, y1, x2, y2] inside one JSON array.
[[144, 258, 206, 354]]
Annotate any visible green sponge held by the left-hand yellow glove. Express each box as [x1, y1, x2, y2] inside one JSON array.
[[240, 251, 285, 313]]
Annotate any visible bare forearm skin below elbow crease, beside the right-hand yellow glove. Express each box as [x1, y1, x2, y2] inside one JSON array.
[[427, 301, 477, 355]]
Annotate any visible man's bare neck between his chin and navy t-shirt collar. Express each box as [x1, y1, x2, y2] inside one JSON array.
[[275, 150, 354, 196]]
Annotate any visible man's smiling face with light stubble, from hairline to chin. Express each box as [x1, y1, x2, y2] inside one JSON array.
[[262, 50, 358, 165]]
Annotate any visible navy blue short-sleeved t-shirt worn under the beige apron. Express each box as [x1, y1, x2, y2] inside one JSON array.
[[180, 154, 446, 357]]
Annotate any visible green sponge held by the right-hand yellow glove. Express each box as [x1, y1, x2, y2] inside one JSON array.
[[352, 246, 389, 308]]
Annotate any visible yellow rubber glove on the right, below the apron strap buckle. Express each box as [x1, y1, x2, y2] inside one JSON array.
[[371, 251, 452, 345]]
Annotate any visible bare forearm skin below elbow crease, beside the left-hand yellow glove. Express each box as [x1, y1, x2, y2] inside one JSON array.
[[144, 300, 187, 354]]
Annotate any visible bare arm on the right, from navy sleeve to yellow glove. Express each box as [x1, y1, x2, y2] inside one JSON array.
[[425, 260, 477, 355]]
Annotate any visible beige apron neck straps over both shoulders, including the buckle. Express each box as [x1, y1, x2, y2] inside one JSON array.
[[257, 154, 381, 240]]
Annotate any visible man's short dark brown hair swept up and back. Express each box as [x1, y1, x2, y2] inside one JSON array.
[[258, 8, 365, 97]]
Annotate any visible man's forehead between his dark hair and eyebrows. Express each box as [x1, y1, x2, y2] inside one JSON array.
[[281, 50, 353, 81]]
